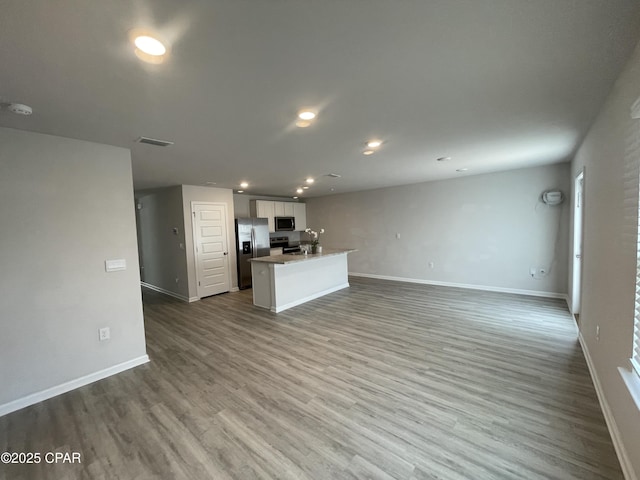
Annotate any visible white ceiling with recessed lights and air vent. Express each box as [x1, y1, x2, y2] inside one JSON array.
[[0, 0, 640, 196]]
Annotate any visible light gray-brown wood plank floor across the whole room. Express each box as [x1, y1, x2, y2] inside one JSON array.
[[0, 278, 623, 480]]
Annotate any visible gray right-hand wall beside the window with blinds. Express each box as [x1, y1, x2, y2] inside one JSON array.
[[572, 36, 640, 478]]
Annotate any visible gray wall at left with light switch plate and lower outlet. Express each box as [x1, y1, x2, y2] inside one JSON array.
[[0, 128, 146, 406]]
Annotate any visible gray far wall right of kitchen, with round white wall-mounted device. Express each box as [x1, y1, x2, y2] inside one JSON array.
[[306, 164, 570, 294]]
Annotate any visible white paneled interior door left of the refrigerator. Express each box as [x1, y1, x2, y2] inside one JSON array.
[[191, 202, 231, 298]]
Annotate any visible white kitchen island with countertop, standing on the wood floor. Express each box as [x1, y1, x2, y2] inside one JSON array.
[[249, 249, 355, 312]]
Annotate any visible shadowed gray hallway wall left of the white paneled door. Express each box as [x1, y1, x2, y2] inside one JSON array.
[[136, 186, 192, 300]]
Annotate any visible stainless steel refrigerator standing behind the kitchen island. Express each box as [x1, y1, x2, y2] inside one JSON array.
[[236, 218, 270, 289]]
